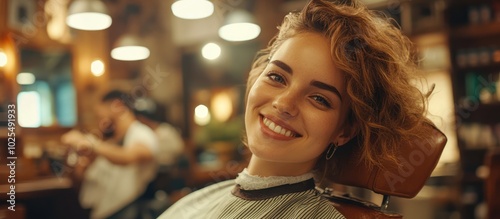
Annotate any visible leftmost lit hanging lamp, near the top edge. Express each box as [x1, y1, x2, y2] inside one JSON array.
[[66, 0, 111, 30]]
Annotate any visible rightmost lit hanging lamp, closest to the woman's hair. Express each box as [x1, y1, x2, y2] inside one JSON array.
[[219, 10, 260, 41]]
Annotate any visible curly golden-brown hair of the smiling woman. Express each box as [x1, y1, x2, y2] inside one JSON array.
[[247, 0, 431, 175]]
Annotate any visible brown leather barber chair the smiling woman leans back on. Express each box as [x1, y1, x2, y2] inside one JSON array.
[[323, 124, 447, 219]]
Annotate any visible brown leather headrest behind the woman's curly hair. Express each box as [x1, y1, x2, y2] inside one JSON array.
[[329, 124, 447, 198]]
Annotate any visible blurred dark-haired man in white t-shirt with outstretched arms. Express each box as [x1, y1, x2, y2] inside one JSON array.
[[61, 91, 158, 218]]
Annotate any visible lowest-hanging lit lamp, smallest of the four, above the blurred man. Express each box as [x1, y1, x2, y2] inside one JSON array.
[[111, 34, 150, 61]]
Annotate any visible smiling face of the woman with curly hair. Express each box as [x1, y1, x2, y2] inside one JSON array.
[[245, 33, 351, 168]]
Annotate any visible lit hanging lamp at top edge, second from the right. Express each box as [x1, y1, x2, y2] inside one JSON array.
[[171, 0, 214, 19]]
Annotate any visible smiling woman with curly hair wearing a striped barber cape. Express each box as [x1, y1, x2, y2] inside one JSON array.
[[160, 0, 440, 218]]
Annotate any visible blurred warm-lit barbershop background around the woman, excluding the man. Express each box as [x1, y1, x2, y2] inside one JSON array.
[[0, 0, 500, 218]]
